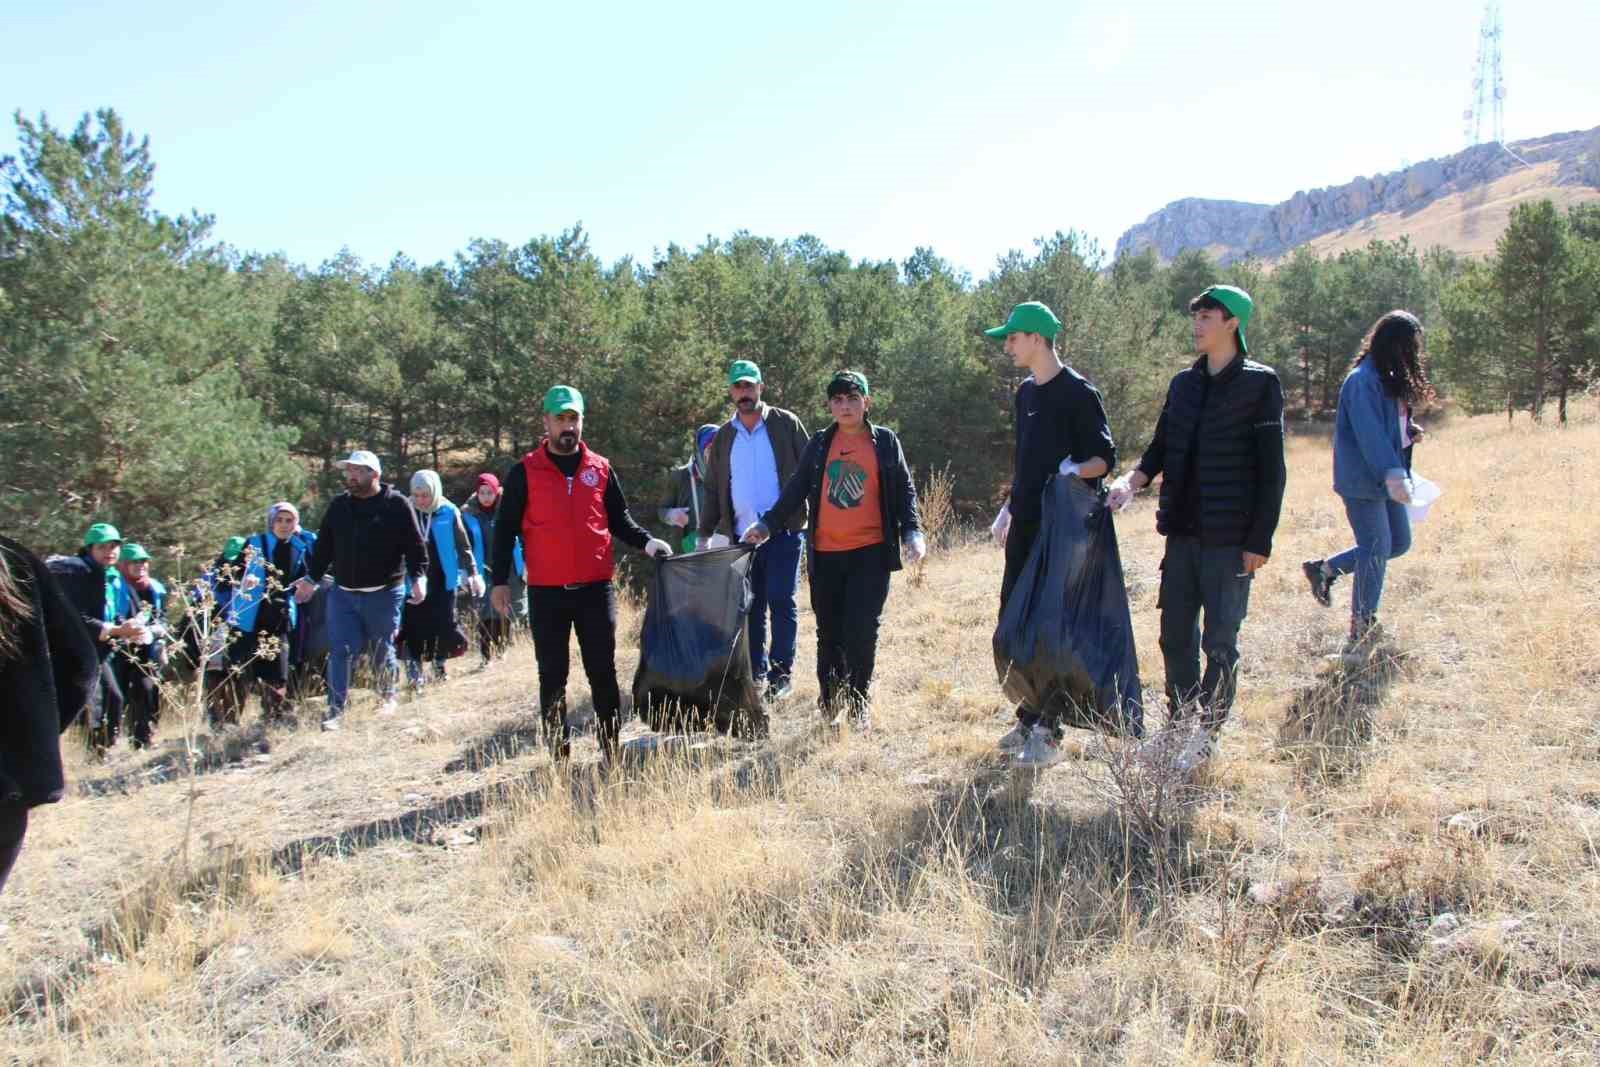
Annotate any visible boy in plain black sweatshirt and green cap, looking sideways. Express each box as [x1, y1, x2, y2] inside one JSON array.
[[984, 301, 1117, 769]]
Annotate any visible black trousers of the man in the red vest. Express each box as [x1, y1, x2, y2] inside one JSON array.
[[528, 582, 622, 758]]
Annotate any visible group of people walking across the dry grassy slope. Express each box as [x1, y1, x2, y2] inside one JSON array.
[[0, 285, 1432, 881]]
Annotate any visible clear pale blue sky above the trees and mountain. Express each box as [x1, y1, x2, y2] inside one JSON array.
[[0, 0, 1600, 277]]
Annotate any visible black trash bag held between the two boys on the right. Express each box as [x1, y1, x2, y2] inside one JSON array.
[[995, 477, 1144, 737]]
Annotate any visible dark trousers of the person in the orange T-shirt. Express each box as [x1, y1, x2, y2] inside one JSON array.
[[811, 544, 890, 709]]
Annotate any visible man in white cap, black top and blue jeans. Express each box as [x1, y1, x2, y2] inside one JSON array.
[[294, 451, 427, 729]]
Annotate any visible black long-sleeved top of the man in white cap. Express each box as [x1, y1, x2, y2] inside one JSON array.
[[306, 485, 427, 589]]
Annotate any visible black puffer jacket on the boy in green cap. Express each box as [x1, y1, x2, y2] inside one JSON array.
[[1139, 355, 1286, 555]]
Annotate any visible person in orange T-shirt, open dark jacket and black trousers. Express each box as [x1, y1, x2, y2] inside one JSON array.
[[744, 371, 928, 729]]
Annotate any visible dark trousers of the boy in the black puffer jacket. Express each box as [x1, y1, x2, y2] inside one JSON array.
[[1157, 537, 1253, 729]]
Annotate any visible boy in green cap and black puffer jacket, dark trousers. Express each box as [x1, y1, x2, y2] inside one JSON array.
[[1107, 285, 1285, 771]]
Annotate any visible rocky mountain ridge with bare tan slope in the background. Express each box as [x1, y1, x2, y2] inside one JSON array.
[[1115, 126, 1600, 262]]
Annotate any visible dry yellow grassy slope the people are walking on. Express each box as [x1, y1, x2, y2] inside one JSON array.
[[0, 405, 1600, 1065]]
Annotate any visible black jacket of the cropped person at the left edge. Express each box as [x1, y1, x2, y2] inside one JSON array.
[[0, 537, 104, 808]]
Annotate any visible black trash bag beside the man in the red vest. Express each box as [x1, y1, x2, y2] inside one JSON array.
[[634, 545, 766, 737]]
